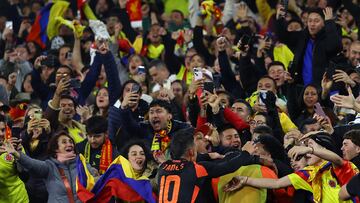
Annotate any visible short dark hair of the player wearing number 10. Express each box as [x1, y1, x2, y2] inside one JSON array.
[[170, 127, 195, 159]]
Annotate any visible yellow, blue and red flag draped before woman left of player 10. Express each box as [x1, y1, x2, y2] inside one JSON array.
[[76, 155, 156, 203]]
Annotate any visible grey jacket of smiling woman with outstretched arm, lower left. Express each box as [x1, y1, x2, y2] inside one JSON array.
[[18, 153, 91, 203]]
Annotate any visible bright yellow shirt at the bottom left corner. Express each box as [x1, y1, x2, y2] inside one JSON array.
[[0, 153, 29, 203]]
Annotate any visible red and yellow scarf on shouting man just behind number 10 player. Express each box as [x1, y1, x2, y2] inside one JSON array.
[[151, 121, 172, 152]]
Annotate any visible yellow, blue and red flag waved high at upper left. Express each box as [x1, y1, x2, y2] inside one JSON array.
[[26, 1, 70, 49]]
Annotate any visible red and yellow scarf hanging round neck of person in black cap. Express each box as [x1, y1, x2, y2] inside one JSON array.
[[85, 138, 112, 174]]
